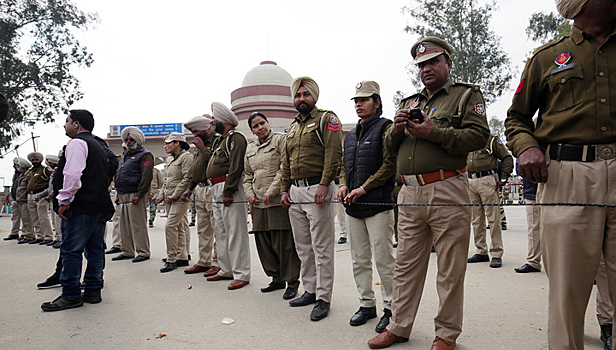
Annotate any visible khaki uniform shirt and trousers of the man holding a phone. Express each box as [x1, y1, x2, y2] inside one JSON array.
[[385, 80, 489, 341]]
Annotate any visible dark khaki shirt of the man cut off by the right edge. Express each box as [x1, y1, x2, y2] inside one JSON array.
[[505, 26, 616, 157]]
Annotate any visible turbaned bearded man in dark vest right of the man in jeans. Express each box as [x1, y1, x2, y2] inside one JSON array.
[[111, 126, 154, 263]]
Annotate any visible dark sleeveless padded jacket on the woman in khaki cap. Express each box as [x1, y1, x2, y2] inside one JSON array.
[[344, 118, 394, 219]]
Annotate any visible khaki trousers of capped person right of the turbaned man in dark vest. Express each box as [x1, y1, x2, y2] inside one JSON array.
[[165, 201, 190, 263]]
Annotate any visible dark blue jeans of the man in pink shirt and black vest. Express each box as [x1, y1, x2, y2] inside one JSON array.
[[60, 210, 110, 299]]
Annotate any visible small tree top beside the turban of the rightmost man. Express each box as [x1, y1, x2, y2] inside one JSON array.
[[526, 12, 571, 43]]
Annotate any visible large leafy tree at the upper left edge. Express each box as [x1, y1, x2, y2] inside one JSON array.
[[0, 0, 98, 149]]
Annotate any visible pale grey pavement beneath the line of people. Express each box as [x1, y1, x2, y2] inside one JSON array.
[[0, 207, 603, 350]]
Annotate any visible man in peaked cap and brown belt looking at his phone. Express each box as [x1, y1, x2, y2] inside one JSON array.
[[368, 37, 489, 350]]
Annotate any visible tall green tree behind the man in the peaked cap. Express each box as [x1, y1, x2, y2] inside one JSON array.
[[402, 0, 512, 103]]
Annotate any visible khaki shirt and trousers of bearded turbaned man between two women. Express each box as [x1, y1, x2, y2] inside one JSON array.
[[281, 107, 342, 303]]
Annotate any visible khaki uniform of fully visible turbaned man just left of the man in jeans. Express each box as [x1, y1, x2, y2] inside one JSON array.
[[26, 164, 53, 241]]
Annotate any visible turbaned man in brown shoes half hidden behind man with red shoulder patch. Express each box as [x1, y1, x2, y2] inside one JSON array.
[[182, 114, 220, 277]]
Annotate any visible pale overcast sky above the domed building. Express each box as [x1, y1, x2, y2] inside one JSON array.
[[0, 0, 555, 185]]
